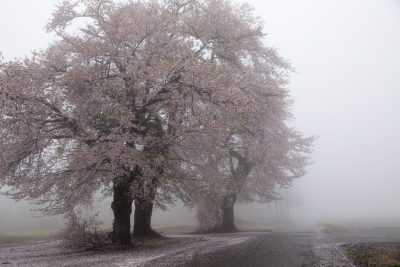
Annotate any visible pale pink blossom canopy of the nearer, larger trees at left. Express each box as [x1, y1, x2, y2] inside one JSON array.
[[0, 0, 278, 216]]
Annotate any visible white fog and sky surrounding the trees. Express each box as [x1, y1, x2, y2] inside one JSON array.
[[0, 0, 400, 231]]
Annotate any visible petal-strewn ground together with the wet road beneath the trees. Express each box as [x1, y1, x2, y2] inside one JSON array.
[[0, 226, 400, 267]]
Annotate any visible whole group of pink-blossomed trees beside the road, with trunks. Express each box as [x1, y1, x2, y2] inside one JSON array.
[[0, 0, 312, 244]]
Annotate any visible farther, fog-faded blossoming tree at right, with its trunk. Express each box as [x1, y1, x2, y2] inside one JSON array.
[[180, 75, 313, 232]]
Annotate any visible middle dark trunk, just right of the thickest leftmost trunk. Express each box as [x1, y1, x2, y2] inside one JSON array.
[[133, 201, 160, 237]]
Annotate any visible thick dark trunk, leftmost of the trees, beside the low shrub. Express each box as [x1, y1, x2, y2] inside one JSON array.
[[111, 181, 132, 245]]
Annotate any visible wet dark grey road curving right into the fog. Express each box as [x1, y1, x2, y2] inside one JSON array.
[[184, 229, 400, 267]]
